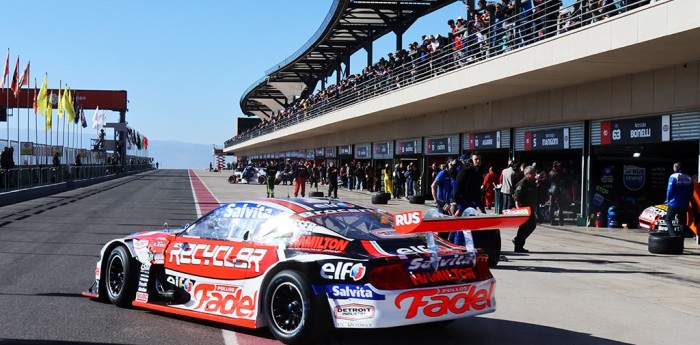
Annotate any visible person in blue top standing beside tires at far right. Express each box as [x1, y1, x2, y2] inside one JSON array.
[[666, 162, 693, 236]]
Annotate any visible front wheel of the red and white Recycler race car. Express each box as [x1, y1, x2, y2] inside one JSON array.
[[100, 246, 139, 308]]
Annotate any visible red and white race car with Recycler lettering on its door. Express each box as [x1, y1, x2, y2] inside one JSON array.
[[83, 198, 529, 344]]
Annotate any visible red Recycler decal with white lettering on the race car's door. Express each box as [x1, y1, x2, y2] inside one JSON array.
[[165, 239, 277, 279]]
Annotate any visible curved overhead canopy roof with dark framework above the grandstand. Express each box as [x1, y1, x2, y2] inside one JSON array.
[[240, 0, 456, 119]]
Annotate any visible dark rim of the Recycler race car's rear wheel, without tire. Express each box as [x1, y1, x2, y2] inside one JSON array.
[[270, 282, 305, 334]]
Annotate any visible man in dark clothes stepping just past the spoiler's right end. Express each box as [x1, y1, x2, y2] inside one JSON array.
[[513, 165, 537, 253]]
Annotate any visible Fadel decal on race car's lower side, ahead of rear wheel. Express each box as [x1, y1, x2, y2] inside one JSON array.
[[192, 284, 258, 319]]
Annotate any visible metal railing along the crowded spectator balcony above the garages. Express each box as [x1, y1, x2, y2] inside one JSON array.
[[224, 0, 673, 147]]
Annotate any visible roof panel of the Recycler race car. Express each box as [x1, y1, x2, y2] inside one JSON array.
[[225, 198, 379, 218]]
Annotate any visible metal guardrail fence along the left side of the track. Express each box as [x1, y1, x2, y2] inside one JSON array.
[[0, 164, 153, 192]]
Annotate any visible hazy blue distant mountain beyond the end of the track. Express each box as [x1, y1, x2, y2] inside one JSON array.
[[148, 140, 231, 169]]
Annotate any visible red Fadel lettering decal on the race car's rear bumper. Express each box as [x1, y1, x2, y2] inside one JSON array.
[[394, 281, 495, 319]]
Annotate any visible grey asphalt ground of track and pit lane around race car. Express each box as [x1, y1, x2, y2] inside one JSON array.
[[0, 170, 700, 345]]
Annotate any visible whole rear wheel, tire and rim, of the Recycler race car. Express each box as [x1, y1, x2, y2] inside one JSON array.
[[263, 270, 330, 344]]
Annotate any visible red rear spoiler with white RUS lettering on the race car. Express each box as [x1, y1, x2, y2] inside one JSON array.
[[394, 207, 531, 234]]
